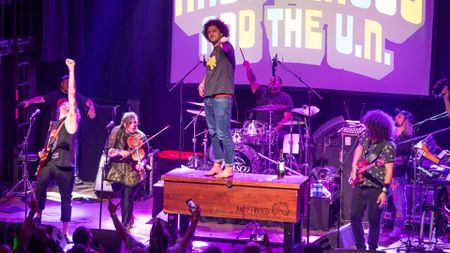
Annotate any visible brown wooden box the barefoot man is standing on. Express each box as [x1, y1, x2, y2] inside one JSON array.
[[163, 169, 306, 223]]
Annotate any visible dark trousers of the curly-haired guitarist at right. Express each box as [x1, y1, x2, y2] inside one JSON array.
[[350, 187, 383, 250]]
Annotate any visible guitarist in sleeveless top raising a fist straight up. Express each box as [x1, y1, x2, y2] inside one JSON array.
[[36, 59, 80, 242]]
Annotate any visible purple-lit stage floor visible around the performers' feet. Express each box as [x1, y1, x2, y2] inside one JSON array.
[[0, 182, 450, 252]]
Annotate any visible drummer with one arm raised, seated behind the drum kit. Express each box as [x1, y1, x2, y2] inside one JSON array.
[[243, 61, 293, 148]]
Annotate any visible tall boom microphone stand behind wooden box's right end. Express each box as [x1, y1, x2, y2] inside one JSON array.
[[275, 59, 323, 243]]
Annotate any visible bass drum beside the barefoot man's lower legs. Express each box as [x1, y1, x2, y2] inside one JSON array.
[[209, 144, 260, 173]]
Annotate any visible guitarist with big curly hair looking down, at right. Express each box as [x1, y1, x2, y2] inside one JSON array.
[[350, 110, 395, 250]]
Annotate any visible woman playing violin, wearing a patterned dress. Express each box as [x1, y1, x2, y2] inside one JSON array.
[[105, 112, 149, 231]]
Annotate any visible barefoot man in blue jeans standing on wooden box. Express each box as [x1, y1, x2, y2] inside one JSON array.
[[198, 19, 236, 178]]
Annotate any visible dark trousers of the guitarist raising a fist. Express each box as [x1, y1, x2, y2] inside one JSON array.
[[36, 161, 75, 222]]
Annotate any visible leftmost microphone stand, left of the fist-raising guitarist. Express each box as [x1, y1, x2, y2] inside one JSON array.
[[6, 114, 36, 219]]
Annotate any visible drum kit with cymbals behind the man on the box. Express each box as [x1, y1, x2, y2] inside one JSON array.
[[185, 101, 320, 174]]
